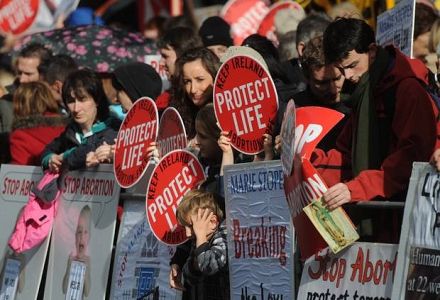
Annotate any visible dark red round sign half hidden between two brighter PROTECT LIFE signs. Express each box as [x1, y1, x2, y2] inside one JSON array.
[[156, 107, 188, 157]]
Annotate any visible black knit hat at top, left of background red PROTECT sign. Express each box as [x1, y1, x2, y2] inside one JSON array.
[[199, 16, 233, 47]]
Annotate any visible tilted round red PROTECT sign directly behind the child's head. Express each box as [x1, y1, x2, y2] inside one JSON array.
[[146, 150, 205, 245]]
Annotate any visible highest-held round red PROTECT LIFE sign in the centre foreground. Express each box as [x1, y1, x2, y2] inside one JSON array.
[[214, 55, 278, 155]]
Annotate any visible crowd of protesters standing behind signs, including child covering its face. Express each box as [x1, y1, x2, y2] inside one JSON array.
[[0, 1, 440, 299]]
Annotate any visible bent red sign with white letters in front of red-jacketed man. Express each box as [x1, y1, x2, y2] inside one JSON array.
[[282, 106, 343, 259]]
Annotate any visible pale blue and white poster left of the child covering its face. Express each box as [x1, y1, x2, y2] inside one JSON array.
[[110, 200, 181, 300]]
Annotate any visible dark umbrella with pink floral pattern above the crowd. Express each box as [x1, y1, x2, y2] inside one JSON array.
[[14, 25, 158, 72]]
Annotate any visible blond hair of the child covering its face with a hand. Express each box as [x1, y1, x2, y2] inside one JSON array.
[[176, 190, 223, 226]]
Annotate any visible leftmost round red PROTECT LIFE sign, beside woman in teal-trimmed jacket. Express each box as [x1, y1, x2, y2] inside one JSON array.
[[113, 97, 159, 188]]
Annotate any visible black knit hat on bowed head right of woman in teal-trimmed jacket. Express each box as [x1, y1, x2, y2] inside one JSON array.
[[112, 62, 162, 102]]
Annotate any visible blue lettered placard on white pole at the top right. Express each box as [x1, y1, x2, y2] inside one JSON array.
[[376, 0, 416, 57]]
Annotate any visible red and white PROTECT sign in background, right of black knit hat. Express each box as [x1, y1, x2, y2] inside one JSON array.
[[220, 0, 269, 45]]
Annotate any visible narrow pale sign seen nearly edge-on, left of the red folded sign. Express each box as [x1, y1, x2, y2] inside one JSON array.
[[280, 100, 296, 176]]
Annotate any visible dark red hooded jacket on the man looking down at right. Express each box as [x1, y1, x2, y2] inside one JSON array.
[[311, 47, 438, 201]]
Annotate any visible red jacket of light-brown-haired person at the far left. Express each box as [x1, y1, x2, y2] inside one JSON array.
[[9, 114, 67, 166]]
